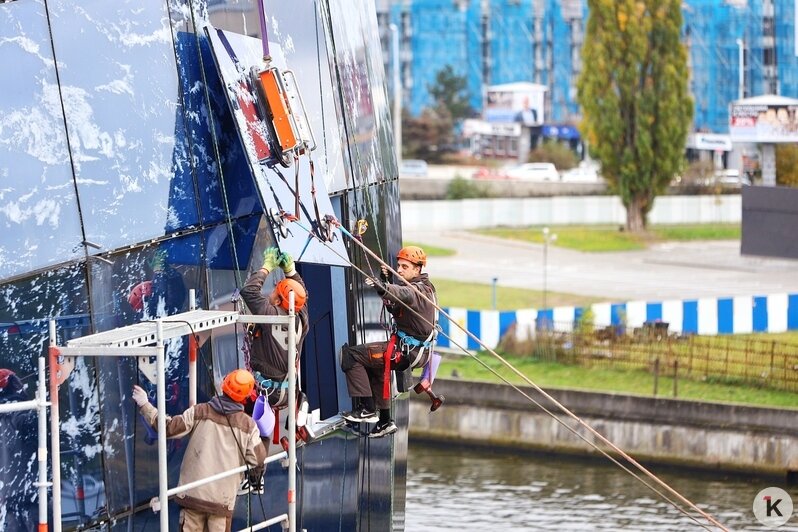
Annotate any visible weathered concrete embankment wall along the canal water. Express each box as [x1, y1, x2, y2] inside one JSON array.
[[410, 379, 798, 476]]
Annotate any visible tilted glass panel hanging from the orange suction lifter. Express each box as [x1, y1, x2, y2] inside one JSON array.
[[207, 28, 347, 265]]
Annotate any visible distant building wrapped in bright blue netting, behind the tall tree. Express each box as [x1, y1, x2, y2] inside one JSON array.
[[377, 0, 798, 134]]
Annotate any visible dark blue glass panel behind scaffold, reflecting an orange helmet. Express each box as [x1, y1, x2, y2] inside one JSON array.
[[85, 233, 202, 513]]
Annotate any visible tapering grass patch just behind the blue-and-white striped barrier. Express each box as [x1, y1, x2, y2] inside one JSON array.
[[432, 278, 606, 310]]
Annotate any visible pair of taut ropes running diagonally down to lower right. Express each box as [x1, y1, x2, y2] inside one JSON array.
[[284, 215, 728, 531]]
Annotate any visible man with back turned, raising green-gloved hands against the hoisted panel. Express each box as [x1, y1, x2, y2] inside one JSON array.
[[241, 247, 308, 408]]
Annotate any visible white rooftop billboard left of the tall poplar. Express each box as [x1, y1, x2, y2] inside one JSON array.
[[484, 82, 546, 127]]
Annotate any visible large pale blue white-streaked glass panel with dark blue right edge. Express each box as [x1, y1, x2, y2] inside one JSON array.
[[47, 0, 198, 249]]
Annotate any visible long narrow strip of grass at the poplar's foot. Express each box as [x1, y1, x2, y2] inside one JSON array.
[[477, 224, 740, 252]]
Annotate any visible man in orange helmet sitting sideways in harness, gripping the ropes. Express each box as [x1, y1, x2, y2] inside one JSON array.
[[341, 246, 436, 438]]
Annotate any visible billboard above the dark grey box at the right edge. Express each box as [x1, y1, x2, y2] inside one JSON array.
[[729, 100, 798, 143]]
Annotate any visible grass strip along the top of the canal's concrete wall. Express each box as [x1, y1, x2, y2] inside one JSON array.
[[438, 353, 798, 408]]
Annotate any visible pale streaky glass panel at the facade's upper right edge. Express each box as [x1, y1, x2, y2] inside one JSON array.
[[328, 0, 398, 191]]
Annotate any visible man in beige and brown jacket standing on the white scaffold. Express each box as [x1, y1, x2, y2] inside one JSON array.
[[132, 369, 267, 532]]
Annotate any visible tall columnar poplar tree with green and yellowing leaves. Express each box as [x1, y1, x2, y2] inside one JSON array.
[[577, 0, 693, 232]]
